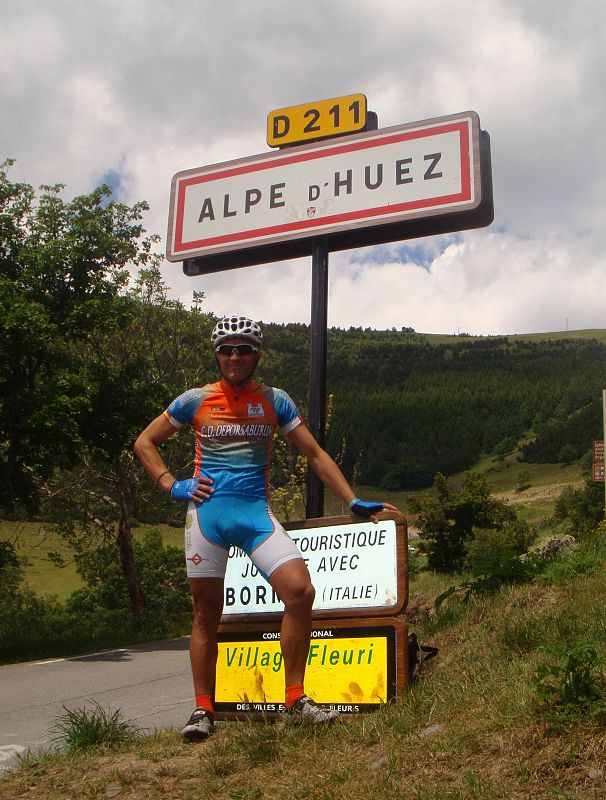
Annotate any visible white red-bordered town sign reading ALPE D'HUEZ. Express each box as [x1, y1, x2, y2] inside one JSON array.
[[166, 111, 482, 261]]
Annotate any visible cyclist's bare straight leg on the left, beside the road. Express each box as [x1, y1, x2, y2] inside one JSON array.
[[189, 578, 223, 696]]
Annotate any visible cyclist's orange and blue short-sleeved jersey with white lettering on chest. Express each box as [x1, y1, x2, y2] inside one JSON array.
[[164, 380, 302, 497]]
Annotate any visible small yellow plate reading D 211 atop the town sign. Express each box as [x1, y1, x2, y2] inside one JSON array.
[[267, 94, 367, 147]]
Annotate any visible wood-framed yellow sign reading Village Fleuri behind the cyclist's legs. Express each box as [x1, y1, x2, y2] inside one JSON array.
[[214, 617, 408, 719]]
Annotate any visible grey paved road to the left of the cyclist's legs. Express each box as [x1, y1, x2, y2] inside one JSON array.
[[0, 637, 193, 773]]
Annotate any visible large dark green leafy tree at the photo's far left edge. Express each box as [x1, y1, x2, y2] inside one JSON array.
[[0, 160, 155, 512]]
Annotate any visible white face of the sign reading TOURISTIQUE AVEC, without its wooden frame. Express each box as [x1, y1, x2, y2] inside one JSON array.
[[223, 520, 398, 618]]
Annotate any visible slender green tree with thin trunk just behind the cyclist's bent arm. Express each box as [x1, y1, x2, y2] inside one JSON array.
[[44, 265, 212, 618]]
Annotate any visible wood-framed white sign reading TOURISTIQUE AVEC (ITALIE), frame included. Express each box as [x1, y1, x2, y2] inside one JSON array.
[[222, 512, 408, 622]]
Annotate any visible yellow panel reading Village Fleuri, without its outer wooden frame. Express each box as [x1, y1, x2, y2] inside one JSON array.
[[215, 629, 393, 713]]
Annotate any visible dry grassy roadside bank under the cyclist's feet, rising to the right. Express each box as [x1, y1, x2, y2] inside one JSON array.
[[0, 542, 606, 800]]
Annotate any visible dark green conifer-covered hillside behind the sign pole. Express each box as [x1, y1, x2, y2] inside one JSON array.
[[262, 325, 606, 489]]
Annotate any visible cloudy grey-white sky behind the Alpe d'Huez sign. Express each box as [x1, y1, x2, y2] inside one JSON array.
[[0, 0, 606, 334]]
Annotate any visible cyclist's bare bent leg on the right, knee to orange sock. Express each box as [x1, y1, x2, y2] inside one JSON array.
[[269, 559, 316, 686]]
